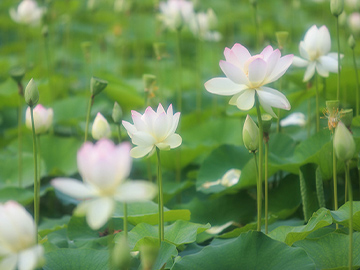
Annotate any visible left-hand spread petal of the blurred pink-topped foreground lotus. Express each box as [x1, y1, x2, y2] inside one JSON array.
[[51, 178, 95, 200]]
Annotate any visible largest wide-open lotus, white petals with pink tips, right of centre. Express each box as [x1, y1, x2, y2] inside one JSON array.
[[205, 43, 293, 117]]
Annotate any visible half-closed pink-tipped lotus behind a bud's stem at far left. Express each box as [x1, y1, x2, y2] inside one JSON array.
[[25, 104, 54, 134]]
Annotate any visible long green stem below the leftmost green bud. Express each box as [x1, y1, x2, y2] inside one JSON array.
[[30, 107, 40, 243]]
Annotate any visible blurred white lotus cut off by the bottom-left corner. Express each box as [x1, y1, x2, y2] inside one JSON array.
[[0, 201, 44, 270]]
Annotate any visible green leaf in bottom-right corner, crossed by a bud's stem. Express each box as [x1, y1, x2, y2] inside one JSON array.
[[294, 233, 360, 270]]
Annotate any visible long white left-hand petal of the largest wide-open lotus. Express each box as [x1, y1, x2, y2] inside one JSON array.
[[205, 78, 247, 96]]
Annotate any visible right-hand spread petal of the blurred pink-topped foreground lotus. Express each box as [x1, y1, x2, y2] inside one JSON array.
[[115, 180, 157, 202]]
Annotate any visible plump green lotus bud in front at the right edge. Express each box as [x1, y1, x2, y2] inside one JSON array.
[[334, 122, 356, 162]]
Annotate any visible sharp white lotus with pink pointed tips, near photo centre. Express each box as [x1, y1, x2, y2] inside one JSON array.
[[122, 104, 182, 158]]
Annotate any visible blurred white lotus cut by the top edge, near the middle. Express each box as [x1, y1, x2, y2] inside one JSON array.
[[159, 0, 194, 30]]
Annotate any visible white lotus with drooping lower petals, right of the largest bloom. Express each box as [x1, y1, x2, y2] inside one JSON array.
[[293, 25, 338, 82]]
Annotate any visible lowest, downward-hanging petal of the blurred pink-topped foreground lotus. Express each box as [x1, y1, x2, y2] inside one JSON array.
[[86, 197, 115, 230]]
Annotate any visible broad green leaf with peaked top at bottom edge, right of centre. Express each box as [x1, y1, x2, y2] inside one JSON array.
[[171, 231, 315, 270]]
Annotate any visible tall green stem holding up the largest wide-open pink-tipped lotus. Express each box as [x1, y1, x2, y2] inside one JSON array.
[[255, 93, 264, 231]]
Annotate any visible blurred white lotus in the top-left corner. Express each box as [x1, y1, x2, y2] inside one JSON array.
[[10, 0, 45, 25]]
